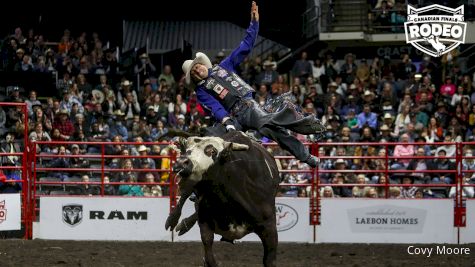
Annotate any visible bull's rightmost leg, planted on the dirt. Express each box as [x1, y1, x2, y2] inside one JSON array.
[[256, 221, 278, 267]]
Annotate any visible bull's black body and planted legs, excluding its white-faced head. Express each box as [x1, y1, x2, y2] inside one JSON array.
[[171, 132, 280, 266]]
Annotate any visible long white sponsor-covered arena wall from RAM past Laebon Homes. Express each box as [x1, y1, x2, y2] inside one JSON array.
[[33, 197, 468, 244]]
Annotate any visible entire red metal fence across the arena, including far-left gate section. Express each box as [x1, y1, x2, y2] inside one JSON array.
[[0, 121, 475, 241]]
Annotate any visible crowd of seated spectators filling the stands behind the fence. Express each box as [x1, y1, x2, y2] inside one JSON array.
[[0, 24, 475, 201]]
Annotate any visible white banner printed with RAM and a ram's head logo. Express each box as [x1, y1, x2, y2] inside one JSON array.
[[33, 197, 171, 241]]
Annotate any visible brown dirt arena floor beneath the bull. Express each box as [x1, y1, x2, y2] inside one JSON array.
[[0, 239, 475, 267]]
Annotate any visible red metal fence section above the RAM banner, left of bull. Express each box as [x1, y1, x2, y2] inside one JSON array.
[[28, 141, 177, 237]]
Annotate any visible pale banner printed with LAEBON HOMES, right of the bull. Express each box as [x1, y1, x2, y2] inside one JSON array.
[[317, 198, 457, 243]]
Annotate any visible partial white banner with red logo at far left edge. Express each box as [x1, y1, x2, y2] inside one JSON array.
[[0, 194, 21, 231]]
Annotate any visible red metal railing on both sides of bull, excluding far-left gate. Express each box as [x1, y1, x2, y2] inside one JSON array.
[[19, 142, 475, 237]]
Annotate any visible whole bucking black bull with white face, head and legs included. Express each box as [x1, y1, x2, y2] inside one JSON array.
[[165, 131, 280, 266]]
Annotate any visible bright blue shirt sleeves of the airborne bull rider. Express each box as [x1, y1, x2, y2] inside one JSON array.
[[195, 21, 259, 122]]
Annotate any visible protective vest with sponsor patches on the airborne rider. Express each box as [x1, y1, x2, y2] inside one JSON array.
[[203, 65, 255, 110]]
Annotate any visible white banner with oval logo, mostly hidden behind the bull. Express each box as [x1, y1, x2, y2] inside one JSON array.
[[174, 197, 313, 243]]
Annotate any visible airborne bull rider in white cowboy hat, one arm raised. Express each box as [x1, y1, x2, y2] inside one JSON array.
[[182, 2, 324, 167]]
